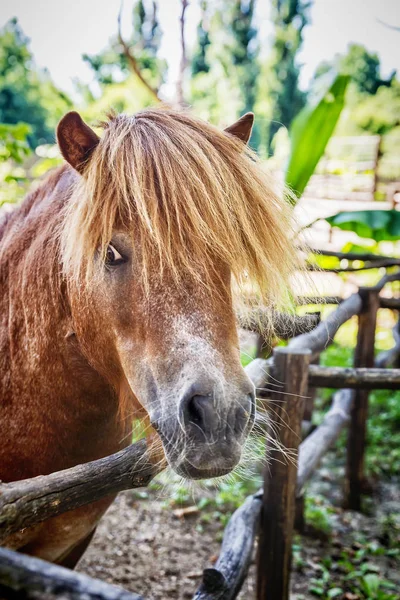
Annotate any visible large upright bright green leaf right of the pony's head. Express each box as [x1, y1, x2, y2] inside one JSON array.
[[285, 75, 349, 198]]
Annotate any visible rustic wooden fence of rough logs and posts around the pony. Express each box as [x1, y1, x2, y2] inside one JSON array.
[[0, 261, 400, 600]]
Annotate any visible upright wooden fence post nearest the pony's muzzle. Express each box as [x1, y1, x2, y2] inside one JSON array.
[[257, 347, 311, 600]]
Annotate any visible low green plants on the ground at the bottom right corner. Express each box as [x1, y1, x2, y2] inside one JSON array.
[[293, 480, 400, 600]]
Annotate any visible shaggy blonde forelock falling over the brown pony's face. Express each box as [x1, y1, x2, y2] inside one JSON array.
[[61, 109, 298, 306]]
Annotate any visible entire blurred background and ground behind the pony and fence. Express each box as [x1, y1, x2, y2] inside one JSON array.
[[0, 0, 400, 600]]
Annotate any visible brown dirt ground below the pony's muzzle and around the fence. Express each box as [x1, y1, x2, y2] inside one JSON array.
[[78, 466, 400, 600]]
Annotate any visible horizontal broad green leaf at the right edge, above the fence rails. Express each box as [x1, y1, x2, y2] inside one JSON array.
[[325, 210, 400, 242]]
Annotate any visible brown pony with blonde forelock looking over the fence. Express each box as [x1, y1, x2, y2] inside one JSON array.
[[0, 109, 295, 567]]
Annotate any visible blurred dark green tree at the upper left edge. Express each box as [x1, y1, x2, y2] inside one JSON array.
[[0, 19, 71, 147]]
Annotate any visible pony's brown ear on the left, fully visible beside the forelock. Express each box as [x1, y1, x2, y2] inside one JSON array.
[[57, 111, 100, 173]]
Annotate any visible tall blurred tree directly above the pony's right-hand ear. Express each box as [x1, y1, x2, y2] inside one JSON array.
[[189, 0, 260, 146]]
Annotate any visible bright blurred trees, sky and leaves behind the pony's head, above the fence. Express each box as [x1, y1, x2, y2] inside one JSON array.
[[0, 0, 400, 270]]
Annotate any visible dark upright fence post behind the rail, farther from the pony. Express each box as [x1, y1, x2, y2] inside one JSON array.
[[344, 288, 379, 510]]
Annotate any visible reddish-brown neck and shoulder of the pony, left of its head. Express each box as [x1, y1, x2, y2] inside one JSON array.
[[0, 167, 130, 481]]
